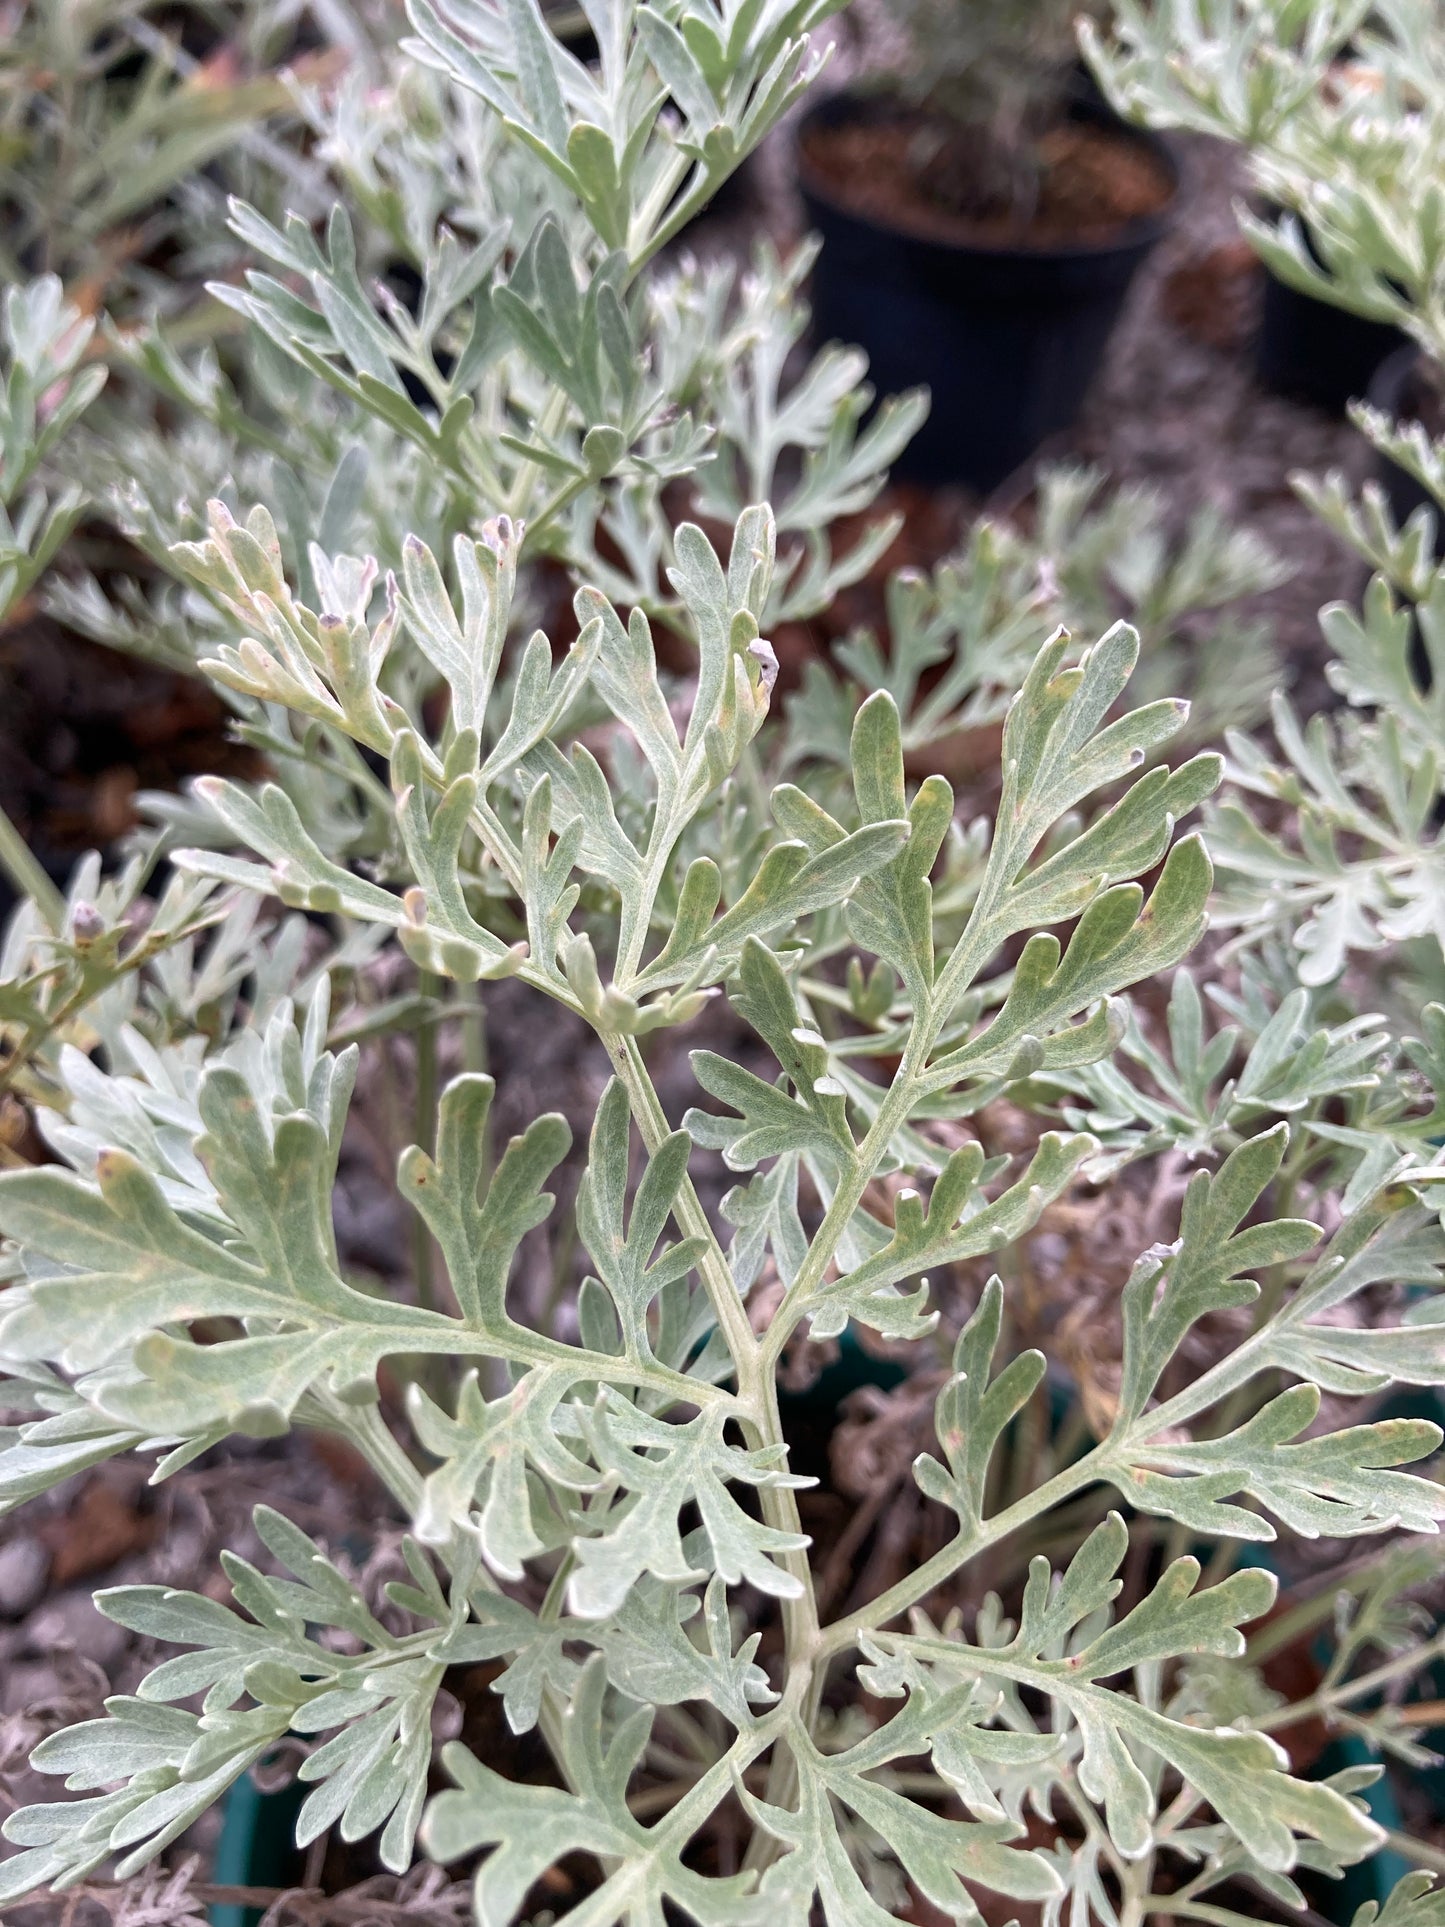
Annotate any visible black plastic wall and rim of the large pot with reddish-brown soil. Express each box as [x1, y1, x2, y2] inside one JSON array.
[[798, 94, 1179, 493]]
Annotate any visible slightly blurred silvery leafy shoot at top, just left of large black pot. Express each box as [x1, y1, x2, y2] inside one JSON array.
[[198, 0, 925, 617]]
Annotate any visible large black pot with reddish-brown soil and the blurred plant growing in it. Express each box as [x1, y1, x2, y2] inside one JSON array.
[[800, 0, 1177, 491]]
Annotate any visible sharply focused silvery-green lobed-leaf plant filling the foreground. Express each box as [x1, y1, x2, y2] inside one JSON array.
[[0, 511, 1445, 1921]]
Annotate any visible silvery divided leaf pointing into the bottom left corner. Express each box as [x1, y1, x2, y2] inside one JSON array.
[[8, 1507, 466, 1888]]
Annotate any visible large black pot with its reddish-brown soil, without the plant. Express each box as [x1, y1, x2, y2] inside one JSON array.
[[800, 94, 1177, 493]]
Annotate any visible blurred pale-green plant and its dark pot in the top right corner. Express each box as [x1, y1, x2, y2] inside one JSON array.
[[1085, 0, 1445, 527]]
